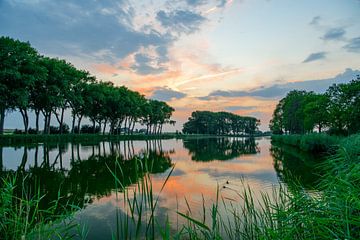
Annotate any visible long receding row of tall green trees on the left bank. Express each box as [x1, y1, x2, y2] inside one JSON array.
[[0, 37, 175, 134]]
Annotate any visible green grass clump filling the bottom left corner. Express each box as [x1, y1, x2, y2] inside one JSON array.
[[0, 176, 87, 240]]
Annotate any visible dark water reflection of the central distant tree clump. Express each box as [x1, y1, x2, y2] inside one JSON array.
[[184, 138, 260, 162]]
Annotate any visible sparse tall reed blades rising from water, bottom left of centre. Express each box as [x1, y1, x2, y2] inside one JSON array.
[[108, 156, 174, 239]]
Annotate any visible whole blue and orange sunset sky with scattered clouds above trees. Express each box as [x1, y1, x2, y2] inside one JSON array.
[[0, 0, 360, 131]]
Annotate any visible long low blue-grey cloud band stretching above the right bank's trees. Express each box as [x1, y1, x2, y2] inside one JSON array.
[[199, 68, 360, 100]]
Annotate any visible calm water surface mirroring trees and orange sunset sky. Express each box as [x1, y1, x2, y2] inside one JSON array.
[[0, 138, 317, 239]]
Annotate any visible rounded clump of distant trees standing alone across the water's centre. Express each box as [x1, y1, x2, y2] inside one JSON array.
[[183, 111, 260, 135]]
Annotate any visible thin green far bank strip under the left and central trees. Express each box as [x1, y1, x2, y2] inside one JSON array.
[[0, 133, 269, 146]]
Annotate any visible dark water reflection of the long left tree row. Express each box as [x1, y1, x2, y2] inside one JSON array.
[[0, 140, 173, 220]]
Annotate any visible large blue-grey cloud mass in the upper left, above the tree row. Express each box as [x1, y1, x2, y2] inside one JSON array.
[[0, 0, 174, 63]]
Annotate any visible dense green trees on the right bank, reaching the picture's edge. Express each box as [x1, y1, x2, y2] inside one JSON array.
[[270, 76, 360, 135]]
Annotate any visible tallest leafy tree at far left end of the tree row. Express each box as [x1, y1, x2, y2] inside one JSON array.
[[0, 37, 45, 134]]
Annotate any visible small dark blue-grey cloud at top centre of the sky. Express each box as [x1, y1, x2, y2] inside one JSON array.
[[156, 10, 206, 34]]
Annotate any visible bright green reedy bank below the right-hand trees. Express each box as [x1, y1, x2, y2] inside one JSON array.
[[271, 133, 342, 153]]
